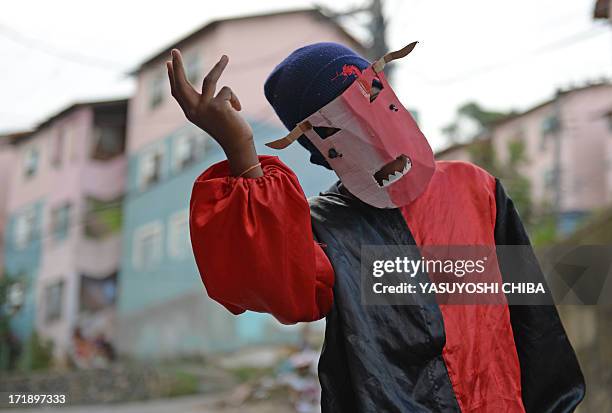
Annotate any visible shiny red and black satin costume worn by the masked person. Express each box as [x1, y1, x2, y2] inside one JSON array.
[[190, 156, 584, 413]]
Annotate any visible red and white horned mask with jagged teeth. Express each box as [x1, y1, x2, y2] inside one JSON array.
[[267, 42, 435, 208]]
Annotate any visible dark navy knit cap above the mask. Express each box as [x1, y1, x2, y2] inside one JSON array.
[[264, 42, 370, 169]]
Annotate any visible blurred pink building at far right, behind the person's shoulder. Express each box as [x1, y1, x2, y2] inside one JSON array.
[[436, 82, 612, 233]]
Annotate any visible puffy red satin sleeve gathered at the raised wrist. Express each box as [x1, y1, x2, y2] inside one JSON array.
[[189, 156, 334, 324]]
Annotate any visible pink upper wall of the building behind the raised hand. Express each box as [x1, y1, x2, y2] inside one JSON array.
[[128, 12, 360, 152]]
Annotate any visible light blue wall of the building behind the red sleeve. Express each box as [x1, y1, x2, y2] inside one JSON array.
[[118, 119, 336, 354]]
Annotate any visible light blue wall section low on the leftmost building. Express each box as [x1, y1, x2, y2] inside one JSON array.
[[4, 200, 43, 341]]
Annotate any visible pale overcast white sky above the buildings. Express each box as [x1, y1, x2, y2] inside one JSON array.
[[0, 0, 612, 149]]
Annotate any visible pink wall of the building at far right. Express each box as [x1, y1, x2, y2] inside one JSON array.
[[439, 84, 612, 216]]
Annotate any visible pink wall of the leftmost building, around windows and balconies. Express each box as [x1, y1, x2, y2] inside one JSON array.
[[7, 105, 126, 356]]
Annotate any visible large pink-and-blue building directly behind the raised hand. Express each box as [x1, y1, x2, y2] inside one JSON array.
[[117, 10, 364, 357]]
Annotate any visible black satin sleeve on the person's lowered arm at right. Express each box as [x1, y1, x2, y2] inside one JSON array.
[[495, 180, 585, 413]]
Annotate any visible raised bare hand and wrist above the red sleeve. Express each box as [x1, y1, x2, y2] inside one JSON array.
[[166, 49, 263, 178]]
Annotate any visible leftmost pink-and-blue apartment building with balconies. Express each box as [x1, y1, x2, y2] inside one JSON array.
[[3, 100, 127, 357]]
